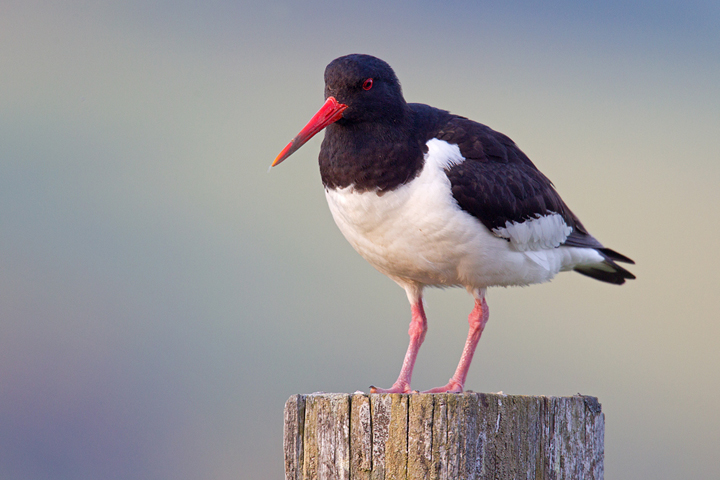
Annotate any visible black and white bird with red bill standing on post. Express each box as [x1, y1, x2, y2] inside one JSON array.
[[272, 54, 635, 393]]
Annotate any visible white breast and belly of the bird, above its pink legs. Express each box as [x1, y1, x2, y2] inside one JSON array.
[[326, 139, 602, 288]]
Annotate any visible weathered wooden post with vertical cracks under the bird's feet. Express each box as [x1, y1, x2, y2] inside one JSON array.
[[284, 392, 605, 480]]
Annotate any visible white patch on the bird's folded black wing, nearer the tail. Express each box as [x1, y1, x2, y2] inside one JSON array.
[[492, 212, 572, 252]]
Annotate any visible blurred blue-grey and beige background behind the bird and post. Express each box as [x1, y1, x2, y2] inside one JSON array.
[[0, 0, 720, 480]]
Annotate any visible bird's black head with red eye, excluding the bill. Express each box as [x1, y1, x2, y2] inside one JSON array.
[[325, 54, 407, 125]]
